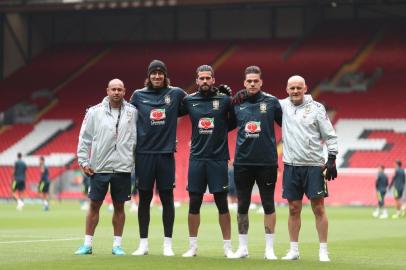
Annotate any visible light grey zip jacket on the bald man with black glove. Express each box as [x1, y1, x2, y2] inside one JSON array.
[[279, 95, 338, 166]]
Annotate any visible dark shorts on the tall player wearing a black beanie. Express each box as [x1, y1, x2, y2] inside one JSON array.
[[136, 153, 175, 190]]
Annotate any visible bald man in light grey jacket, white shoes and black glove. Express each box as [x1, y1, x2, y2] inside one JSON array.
[[280, 75, 338, 262]]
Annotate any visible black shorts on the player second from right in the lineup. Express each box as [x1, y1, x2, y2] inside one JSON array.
[[234, 165, 278, 195]]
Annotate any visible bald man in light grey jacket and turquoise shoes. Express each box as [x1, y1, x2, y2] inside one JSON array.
[[75, 79, 137, 255]]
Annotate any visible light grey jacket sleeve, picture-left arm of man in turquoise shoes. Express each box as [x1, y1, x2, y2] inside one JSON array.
[[77, 108, 94, 167]]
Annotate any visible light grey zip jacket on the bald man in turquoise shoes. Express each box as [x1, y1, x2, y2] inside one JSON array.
[[77, 97, 137, 173]]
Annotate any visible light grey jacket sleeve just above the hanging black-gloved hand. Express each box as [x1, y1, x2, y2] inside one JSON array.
[[317, 104, 338, 155]]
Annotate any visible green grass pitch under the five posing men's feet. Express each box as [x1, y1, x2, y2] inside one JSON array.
[[0, 201, 406, 270]]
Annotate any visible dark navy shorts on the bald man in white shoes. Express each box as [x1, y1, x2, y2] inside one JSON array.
[[282, 164, 328, 201]]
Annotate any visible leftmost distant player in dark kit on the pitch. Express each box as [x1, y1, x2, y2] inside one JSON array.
[[12, 153, 27, 210]]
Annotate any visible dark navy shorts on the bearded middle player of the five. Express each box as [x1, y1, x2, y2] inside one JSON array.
[[187, 159, 228, 194]]
